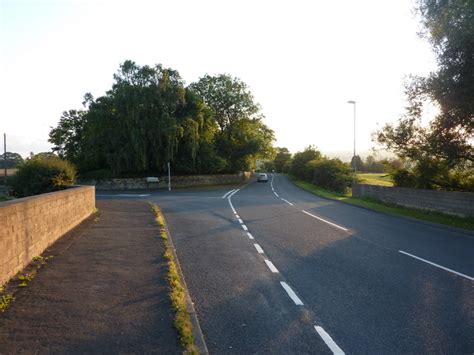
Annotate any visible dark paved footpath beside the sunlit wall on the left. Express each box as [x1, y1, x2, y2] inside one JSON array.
[[0, 200, 182, 354]]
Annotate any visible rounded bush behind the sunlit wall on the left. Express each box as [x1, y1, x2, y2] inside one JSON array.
[[10, 156, 76, 197]]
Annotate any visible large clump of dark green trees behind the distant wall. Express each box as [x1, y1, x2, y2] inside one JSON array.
[[49, 60, 274, 176]]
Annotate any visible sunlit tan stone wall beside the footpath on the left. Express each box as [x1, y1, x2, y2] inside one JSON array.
[[0, 186, 95, 285]]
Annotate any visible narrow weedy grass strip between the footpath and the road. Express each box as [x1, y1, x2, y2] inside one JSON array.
[[152, 204, 199, 354]]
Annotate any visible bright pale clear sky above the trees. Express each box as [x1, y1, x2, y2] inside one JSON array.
[[0, 0, 435, 159]]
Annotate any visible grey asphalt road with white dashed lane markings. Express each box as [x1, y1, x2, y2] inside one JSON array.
[[99, 175, 474, 354]]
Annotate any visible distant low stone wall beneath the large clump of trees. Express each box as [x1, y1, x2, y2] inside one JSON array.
[[82, 172, 251, 191]]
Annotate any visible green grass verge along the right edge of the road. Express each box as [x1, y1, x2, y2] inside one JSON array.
[[289, 176, 474, 230]]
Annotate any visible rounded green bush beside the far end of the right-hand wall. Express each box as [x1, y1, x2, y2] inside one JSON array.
[[306, 158, 352, 193]]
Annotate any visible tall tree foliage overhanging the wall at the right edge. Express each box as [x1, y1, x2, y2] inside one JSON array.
[[377, 0, 474, 189]]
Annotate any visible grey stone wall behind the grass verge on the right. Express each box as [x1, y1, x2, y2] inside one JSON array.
[[352, 184, 474, 217]]
